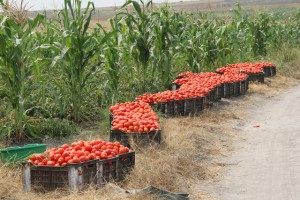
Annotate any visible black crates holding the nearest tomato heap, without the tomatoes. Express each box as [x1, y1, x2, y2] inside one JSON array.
[[22, 152, 135, 192]]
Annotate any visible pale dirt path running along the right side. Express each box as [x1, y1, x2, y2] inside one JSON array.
[[201, 85, 300, 200]]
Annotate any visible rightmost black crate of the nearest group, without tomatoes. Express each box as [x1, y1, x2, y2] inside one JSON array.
[[116, 151, 135, 181]]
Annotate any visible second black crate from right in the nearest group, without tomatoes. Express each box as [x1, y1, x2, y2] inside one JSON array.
[[97, 157, 117, 185]]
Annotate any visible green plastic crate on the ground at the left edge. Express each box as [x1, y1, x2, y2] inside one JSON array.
[[0, 144, 46, 163]]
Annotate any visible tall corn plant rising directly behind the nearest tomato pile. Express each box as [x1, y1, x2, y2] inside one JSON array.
[[49, 0, 106, 123]]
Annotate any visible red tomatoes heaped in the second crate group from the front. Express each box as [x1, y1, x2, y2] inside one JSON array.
[[110, 102, 160, 133]]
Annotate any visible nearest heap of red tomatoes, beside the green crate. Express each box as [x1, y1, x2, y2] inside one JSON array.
[[28, 140, 131, 167]]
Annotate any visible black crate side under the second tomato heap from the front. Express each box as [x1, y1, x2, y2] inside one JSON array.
[[110, 130, 161, 147]]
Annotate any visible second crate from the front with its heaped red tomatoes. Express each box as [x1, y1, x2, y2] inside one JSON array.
[[110, 102, 161, 147]]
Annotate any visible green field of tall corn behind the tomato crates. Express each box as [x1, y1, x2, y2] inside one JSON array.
[[0, 0, 300, 141]]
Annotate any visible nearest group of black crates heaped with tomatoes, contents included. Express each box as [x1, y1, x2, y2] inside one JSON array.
[[23, 140, 135, 192]]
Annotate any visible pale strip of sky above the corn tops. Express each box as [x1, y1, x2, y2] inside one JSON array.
[[7, 0, 197, 10]]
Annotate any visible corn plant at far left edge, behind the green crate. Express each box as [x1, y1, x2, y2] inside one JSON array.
[[0, 12, 43, 141]]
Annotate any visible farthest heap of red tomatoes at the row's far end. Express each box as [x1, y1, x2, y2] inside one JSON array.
[[216, 62, 275, 74]]
